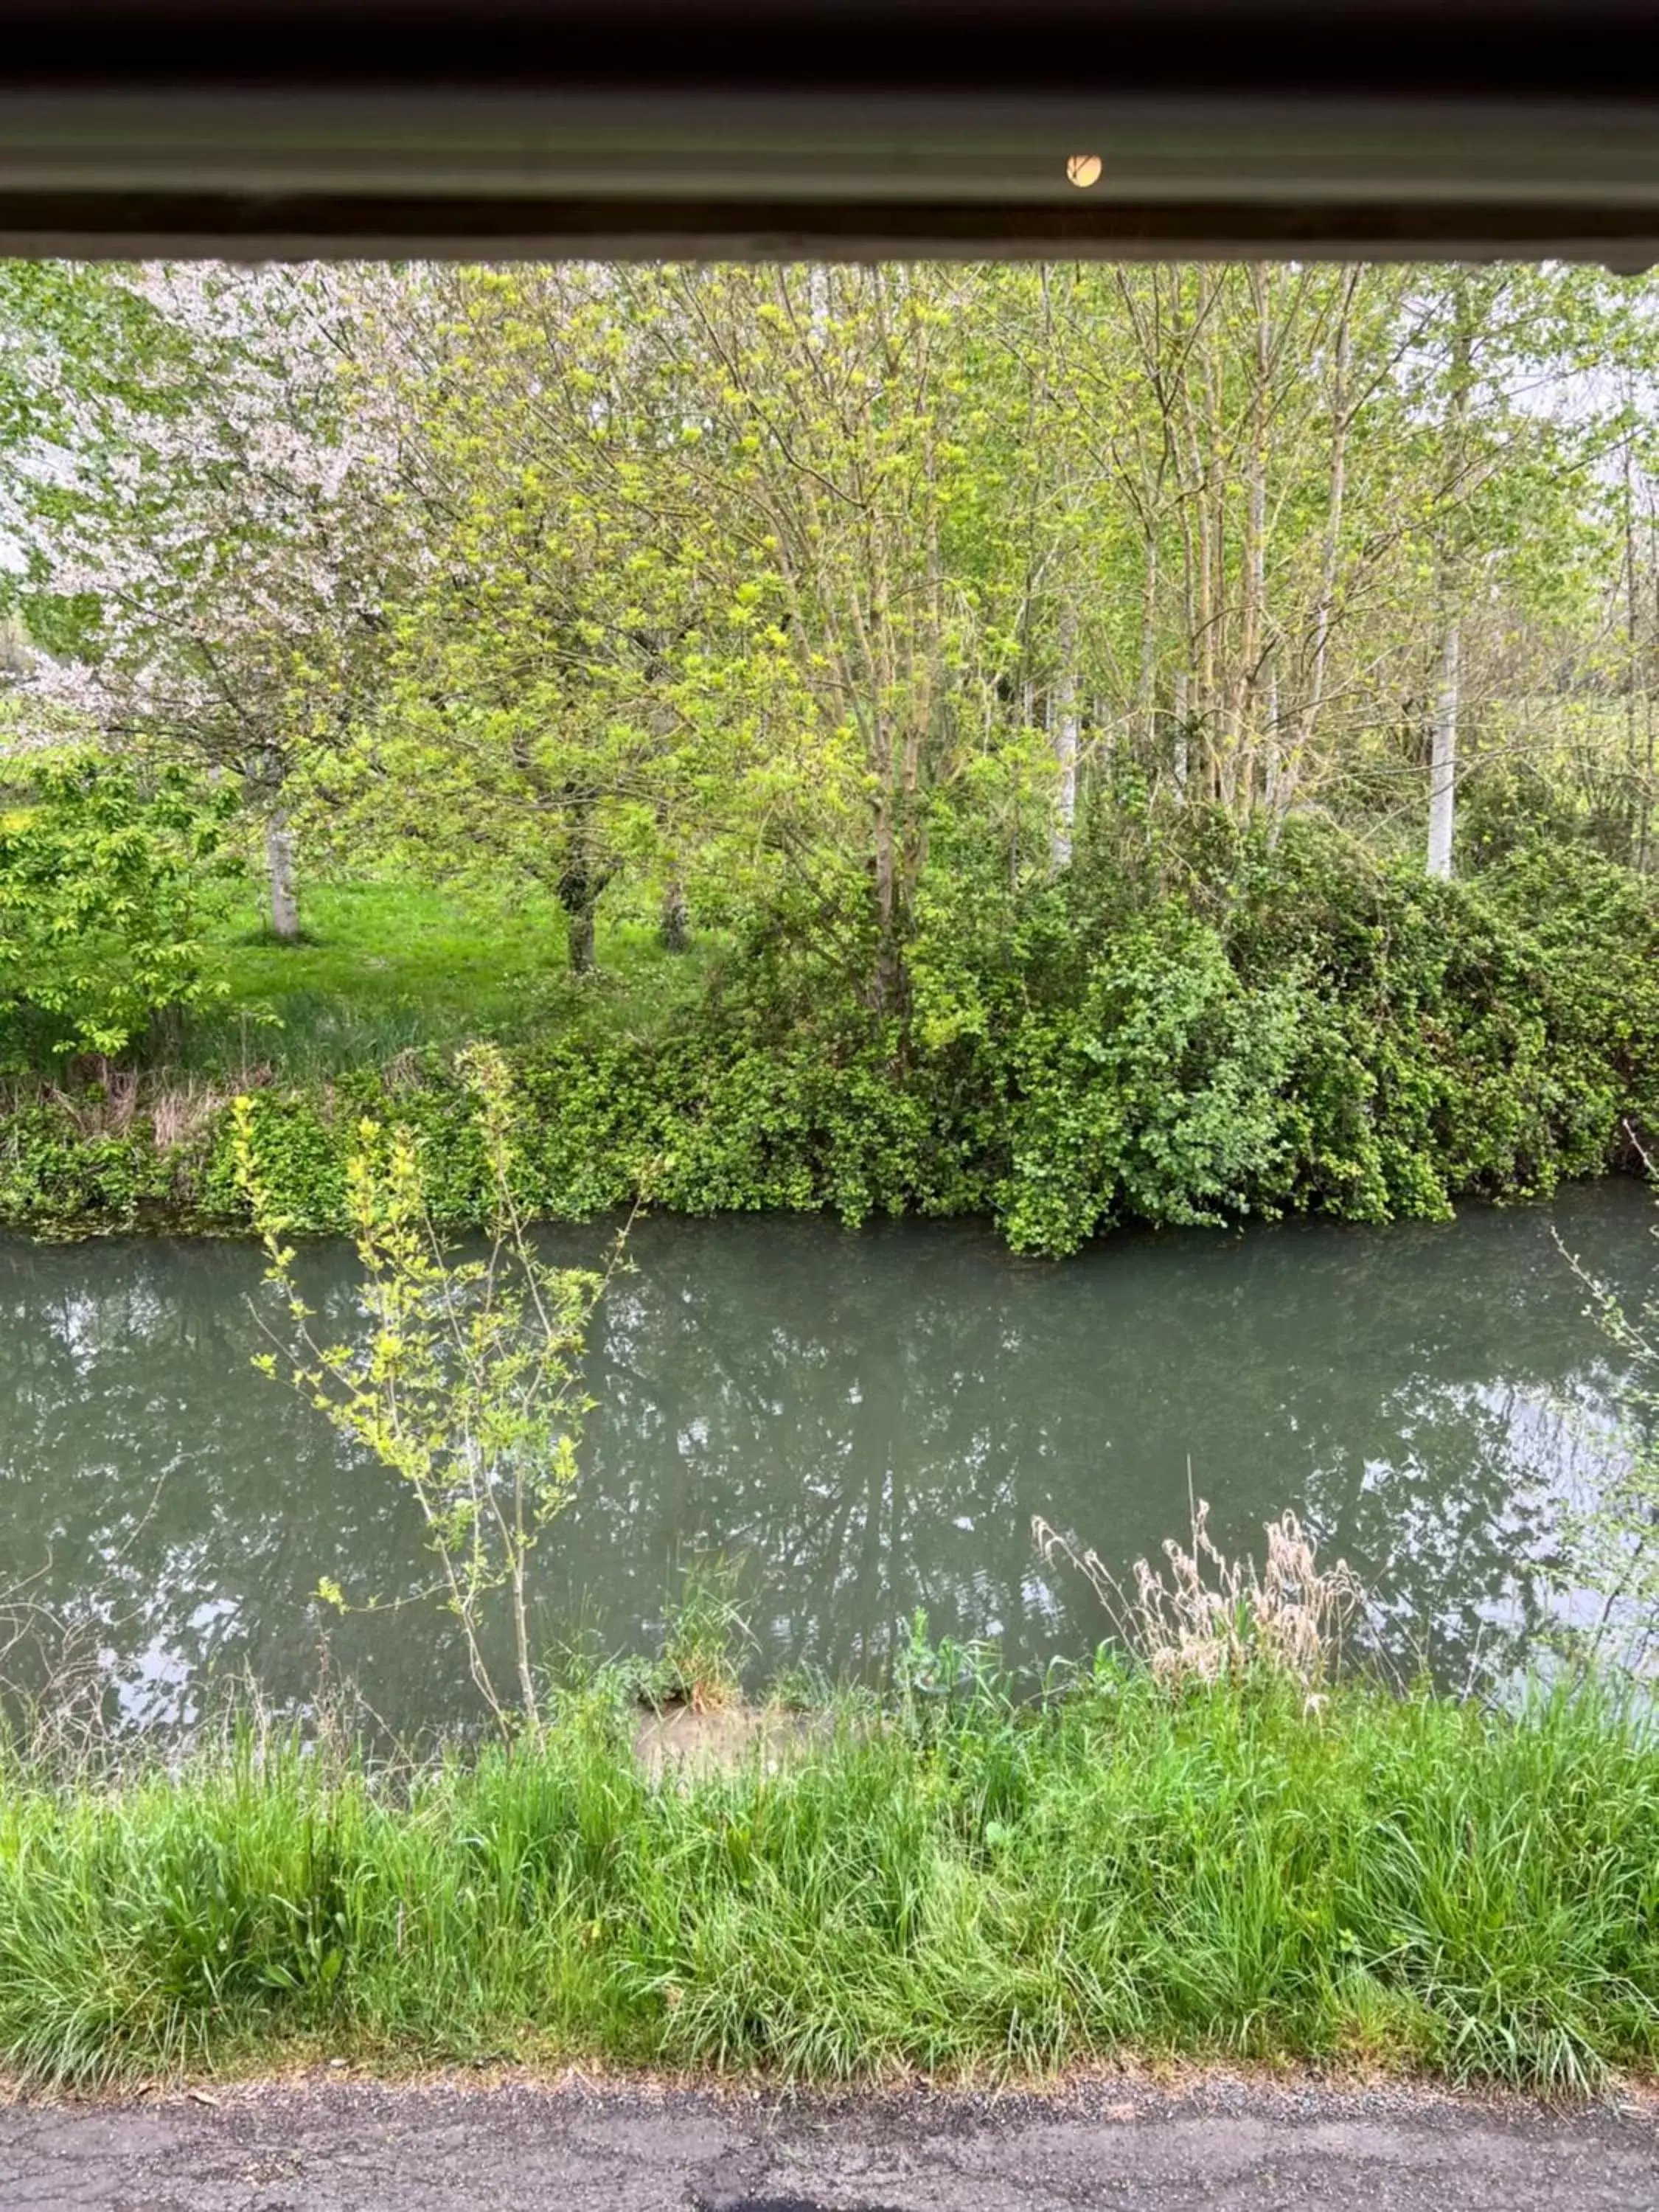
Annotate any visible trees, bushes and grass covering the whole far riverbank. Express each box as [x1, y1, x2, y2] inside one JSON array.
[[0, 265, 1659, 1252]]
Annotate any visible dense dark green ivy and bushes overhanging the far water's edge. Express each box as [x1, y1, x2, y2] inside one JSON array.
[[0, 823, 1659, 1254]]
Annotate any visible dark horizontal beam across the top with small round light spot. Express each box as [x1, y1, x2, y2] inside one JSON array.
[[0, 0, 1659, 265]]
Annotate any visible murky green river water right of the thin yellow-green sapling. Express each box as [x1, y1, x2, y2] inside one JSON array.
[[555, 1194, 1632, 1666]]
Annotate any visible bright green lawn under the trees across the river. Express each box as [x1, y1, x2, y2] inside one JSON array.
[[166, 880, 712, 1079]]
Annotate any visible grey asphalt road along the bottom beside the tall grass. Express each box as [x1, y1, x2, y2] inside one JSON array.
[[0, 2077, 1659, 2212]]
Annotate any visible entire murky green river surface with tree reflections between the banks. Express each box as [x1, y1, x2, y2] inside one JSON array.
[[0, 1188, 1648, 1725]]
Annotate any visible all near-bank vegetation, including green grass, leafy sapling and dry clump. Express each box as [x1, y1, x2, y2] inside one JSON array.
[[0, 1150, 1659, 2093]]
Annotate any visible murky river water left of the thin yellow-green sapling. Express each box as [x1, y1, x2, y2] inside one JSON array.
[[0, 1245, 471, 1719]]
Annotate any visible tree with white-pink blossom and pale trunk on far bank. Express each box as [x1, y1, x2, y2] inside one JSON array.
[[27, 263, 414, 938]]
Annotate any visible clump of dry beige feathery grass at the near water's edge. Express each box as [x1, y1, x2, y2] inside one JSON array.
[[1031, 1498, 1365, 1692]]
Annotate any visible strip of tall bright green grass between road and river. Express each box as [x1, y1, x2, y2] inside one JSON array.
[[0, 1672, 1659, 2088]]
